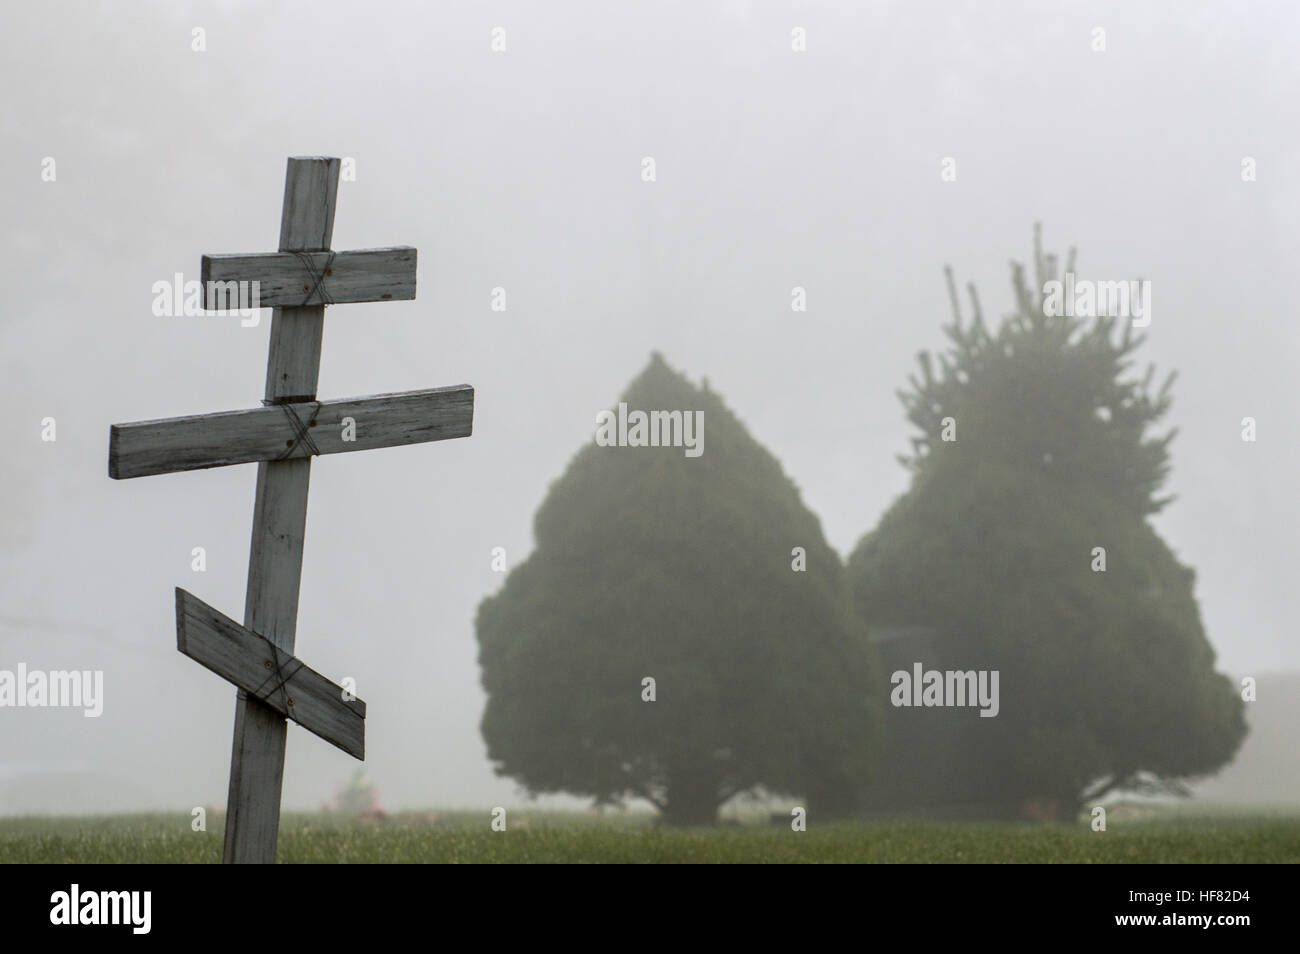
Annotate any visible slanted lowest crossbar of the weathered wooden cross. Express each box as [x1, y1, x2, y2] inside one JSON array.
[[176, 586, 365, 759]]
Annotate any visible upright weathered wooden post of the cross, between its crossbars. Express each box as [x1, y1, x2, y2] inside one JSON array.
[[222, 156, 339, 864]]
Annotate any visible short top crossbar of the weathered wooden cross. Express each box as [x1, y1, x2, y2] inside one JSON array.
[[200, 246, 416, 311]]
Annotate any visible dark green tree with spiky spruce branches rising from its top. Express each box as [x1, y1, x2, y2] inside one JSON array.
[[849, 237, 1244, 816]]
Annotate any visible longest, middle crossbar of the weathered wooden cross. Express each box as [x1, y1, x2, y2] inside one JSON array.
[[108, 385, 475, 480]]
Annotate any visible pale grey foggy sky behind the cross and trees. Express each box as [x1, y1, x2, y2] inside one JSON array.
[[0, 0, 1300, 812]]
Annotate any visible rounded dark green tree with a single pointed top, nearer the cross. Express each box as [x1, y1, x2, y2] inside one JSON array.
[[477, 355, 880, 823]]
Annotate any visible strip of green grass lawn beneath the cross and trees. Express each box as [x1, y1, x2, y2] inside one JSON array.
[[0, 808, 1300, 864]]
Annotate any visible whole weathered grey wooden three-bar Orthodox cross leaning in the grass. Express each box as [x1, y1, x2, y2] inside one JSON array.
[[108, 156, 475, 863]]
